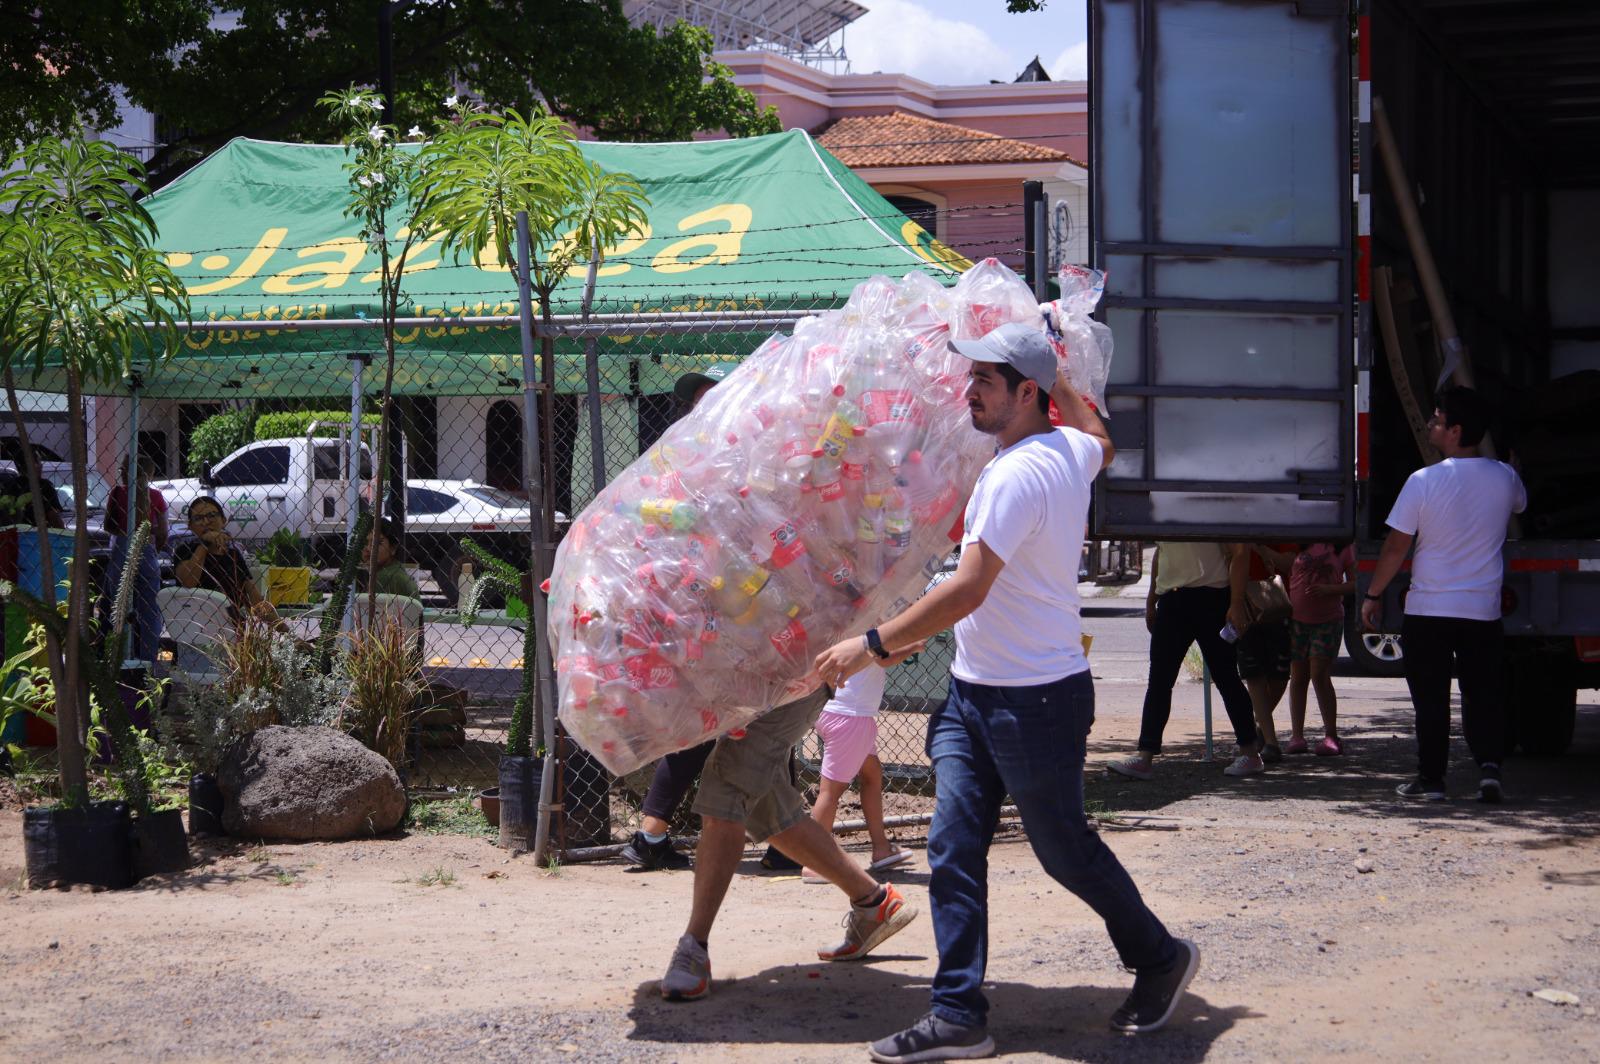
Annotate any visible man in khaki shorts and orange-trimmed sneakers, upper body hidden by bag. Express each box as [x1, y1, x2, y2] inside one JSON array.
[[661, 686, 917, 1002]]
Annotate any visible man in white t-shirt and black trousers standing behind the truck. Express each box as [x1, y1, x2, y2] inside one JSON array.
[[1362, 387, 1528, 805]]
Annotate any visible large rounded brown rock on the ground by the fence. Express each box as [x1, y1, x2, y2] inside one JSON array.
[[218, 726, 405, 838]]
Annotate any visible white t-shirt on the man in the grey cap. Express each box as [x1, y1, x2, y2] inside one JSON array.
[[950, 429, 1102, 686]]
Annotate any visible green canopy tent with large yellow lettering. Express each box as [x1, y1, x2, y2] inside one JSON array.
[[29, 130, 966, 400]]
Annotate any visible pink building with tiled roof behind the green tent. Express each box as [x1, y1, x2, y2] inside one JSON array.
[[717, 51, 1088, 266]]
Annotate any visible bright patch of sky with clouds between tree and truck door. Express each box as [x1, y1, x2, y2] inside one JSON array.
[[825, 0, 1088, 85]]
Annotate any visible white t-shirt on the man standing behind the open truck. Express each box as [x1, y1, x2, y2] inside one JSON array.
[[1389, 458, 1528, 621]]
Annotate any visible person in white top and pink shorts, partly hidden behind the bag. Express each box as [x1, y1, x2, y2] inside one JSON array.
[[800, 667, 910, 883]]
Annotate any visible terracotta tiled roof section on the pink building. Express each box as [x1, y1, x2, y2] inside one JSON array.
[[816, 114, 1070, 166]]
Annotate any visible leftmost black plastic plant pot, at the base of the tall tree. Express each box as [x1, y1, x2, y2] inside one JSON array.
[[22, 802, 133, 890]]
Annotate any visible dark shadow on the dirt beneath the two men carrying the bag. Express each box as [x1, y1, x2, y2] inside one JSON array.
[[627, 958, 1258, 1062]]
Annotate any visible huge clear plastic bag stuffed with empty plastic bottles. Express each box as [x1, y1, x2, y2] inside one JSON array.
[[549, 259, 1104, 774]]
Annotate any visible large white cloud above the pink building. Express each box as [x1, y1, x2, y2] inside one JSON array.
[[845, 0, 1011, 85]]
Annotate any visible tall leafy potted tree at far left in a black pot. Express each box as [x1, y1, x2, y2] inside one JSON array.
[[0, 130, 187, 885]]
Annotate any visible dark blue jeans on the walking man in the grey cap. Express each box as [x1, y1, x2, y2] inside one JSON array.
[[928, 670, 1178, 1027]]
